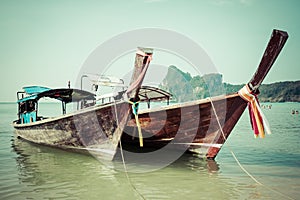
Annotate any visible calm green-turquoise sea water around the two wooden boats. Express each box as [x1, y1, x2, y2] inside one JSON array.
[[0, 103, 300, 200]]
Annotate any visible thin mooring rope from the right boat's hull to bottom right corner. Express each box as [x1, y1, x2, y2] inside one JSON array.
[[209, 97, 295, 200]]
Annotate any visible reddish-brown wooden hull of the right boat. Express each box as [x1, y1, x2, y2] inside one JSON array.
[[122, 94, 247, 159]]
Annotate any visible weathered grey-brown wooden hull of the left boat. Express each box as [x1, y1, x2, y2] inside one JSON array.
[[13, 102, 129, 160]]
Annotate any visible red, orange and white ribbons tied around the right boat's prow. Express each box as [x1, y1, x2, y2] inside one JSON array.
[[238, 85, 271, 138]]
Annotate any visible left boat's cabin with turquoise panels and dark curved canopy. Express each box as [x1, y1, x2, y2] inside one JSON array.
[[17, 86, 96, 124]]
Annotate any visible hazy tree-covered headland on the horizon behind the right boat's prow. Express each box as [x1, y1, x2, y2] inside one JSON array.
[[160, 65, 300, 102]]
